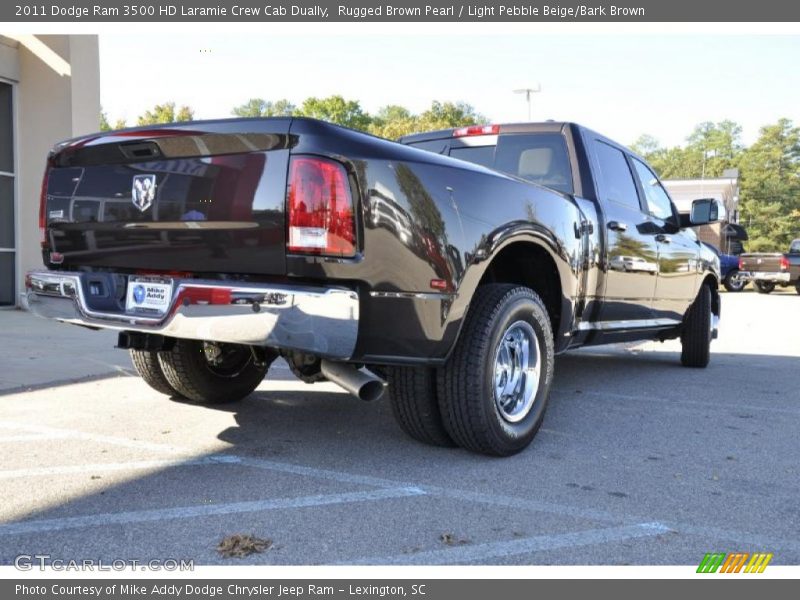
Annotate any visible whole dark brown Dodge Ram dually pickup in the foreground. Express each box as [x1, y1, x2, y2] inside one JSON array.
[[24, 118, 720, 455]]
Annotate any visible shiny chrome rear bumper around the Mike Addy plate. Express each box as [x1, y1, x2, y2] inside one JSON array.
[[22, 271, 359, 360]]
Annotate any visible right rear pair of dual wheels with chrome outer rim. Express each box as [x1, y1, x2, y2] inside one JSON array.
[[387, 284, 555, 456]]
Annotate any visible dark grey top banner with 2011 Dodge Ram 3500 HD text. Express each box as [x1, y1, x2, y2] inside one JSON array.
[[0, 0, 800, 23]]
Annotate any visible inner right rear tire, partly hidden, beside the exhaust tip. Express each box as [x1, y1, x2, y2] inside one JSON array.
[[385, 367, 455, 447]]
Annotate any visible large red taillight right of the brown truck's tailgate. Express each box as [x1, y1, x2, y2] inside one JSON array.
[[287, 156, 356, 256]]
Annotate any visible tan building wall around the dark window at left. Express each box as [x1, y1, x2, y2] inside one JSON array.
[[0, 35, 100, 302]]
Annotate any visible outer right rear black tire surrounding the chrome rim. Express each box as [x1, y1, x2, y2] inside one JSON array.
[[437, 284, 555, 456]]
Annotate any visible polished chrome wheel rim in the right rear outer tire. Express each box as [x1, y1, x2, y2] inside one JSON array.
[[492, 321, 541, 423]]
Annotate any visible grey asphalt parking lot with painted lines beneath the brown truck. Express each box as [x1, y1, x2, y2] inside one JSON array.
[[0, 290, 800, 565]]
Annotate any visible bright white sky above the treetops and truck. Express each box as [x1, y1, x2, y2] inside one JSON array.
[[100, 34, 800, 145]]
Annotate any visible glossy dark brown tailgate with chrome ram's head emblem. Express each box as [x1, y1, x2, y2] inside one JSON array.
[[40, 119, 292, 275]]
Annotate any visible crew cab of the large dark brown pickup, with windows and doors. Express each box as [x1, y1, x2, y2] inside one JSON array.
[[400, 122, 720, 346]]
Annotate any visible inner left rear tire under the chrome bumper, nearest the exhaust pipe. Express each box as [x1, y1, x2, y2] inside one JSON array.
[[158, 340, 275, 404]]
